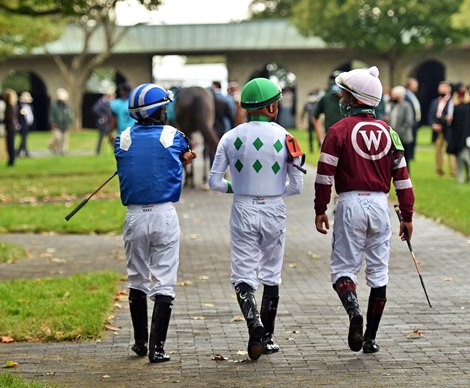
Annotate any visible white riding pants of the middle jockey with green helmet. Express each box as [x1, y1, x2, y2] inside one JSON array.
[[230, 195, 287, 290]]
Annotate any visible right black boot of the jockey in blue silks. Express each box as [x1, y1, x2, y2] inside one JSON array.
[[149, 295, 173, 363]]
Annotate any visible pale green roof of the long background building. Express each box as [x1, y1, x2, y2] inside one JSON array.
[[32, 19, 326, 55]]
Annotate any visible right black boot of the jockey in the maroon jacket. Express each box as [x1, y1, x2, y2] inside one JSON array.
[[362, 286, 387, 353]]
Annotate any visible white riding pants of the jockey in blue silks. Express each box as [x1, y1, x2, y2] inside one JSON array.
[[124, 202, 180, 300]]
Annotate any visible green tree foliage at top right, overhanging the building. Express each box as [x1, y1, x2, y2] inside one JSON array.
[[293, 0, 462, 57]]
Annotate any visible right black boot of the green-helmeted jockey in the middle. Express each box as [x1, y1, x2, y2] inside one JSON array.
[[260, 285, 279, 354]]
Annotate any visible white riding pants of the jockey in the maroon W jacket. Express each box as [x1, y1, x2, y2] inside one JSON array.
[[331, 191, 392, 288]]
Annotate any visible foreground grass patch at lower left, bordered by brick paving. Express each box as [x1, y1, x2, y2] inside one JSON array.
[[0, 272, 120, 341]]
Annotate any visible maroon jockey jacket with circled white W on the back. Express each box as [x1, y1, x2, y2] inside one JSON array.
[[315, 114, 414, 222]]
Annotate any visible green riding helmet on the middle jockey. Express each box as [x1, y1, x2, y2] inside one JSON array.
[[241, 78, 282, 110]]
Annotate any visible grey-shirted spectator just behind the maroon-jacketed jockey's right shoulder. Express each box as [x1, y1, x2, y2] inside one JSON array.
[[388, 85, 413, 173]]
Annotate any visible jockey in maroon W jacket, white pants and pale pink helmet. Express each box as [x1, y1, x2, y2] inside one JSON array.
[[314, 66, 414, 353]]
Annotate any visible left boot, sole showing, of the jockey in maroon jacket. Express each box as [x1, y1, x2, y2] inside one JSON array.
[[333, 277, 363, 352]]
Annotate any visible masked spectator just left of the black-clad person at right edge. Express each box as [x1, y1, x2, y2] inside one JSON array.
[[428, 81, 456, 177]]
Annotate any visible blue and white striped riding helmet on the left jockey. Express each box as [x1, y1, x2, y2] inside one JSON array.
[[129, 83, 173, 120]]
